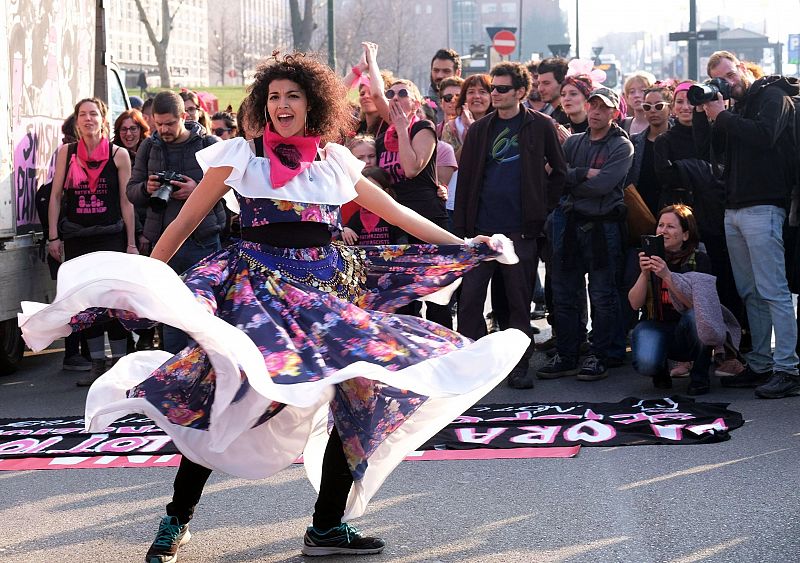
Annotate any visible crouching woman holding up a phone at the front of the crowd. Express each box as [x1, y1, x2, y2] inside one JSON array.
[[628, 204, 719, 395]]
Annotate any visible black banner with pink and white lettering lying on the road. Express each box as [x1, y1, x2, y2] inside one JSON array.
[[0, 397, 743, 469]]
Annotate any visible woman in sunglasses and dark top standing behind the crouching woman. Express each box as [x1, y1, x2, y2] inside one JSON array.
[[625, 86, 681, 217]]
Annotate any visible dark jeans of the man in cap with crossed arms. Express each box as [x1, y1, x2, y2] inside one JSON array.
[[549, 209, 625, 360]]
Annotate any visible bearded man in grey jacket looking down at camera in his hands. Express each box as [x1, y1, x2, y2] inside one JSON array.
[[126, 91, 225, 354]]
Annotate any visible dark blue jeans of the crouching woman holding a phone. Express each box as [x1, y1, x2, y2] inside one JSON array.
[[631, 311, 712, 382]]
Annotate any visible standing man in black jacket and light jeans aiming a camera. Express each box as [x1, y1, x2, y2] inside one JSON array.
[[688, 51, 800, 399]]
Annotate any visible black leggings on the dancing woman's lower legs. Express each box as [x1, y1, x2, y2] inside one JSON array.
[[167, 427, 353, 530]]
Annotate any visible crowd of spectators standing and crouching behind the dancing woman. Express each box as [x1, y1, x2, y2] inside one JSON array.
[[48, 43, 800, 404]]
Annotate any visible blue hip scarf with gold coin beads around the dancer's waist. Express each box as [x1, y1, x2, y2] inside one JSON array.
[[240, 243, 367, 301]]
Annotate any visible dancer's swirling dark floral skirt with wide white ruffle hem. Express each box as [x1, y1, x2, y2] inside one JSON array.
[[20, 238, 529, 518]]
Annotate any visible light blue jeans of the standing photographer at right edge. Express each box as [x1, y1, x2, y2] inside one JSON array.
[[725, 205, 798, 374]]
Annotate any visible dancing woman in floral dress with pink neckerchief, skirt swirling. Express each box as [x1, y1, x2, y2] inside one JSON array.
[[20, 55, 529, 563]]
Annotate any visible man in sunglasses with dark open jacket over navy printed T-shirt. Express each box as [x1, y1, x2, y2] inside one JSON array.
[[453, 62, 566, 389]]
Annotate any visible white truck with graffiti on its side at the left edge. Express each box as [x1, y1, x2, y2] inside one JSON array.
[[0, 0, 129, 374]]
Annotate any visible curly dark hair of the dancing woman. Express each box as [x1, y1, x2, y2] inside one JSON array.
[[242, 51, 354, 142]]
